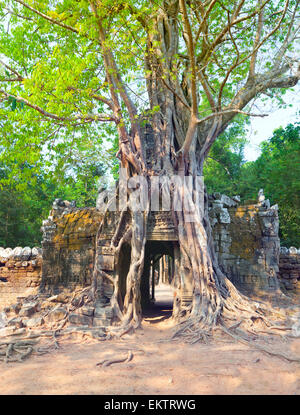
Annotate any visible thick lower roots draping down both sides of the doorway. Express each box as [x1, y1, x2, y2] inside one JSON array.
[[94, 126, 288, 341]]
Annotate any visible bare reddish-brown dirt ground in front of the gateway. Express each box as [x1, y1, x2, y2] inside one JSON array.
[[0, 287, 300, 395]]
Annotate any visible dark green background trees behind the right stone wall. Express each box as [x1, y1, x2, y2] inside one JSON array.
[[241, 123, 300, 247]]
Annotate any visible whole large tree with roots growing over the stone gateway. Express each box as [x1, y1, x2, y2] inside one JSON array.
[[0, 0, 300, 337]]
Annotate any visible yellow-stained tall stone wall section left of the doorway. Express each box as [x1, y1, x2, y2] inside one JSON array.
[[41, 200, 102, 294]]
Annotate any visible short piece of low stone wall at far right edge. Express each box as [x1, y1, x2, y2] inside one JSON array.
[[279, 246, 300, 295]]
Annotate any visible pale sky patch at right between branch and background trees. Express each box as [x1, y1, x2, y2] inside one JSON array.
[[245, 87, 300, 161]]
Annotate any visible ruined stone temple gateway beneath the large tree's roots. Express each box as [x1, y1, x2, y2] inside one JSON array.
[[40, 193, 280, 332]]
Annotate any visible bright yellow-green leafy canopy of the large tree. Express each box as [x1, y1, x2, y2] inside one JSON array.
[[0, 0, 299, 174]]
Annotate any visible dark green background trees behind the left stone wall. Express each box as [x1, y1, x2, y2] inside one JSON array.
[[0, 161, 103, 247]]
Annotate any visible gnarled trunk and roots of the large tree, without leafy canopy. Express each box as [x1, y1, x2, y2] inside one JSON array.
[[90, 1, 290, 339]]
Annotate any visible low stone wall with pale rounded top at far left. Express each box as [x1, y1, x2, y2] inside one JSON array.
[[0, 247, 42, 309]]
